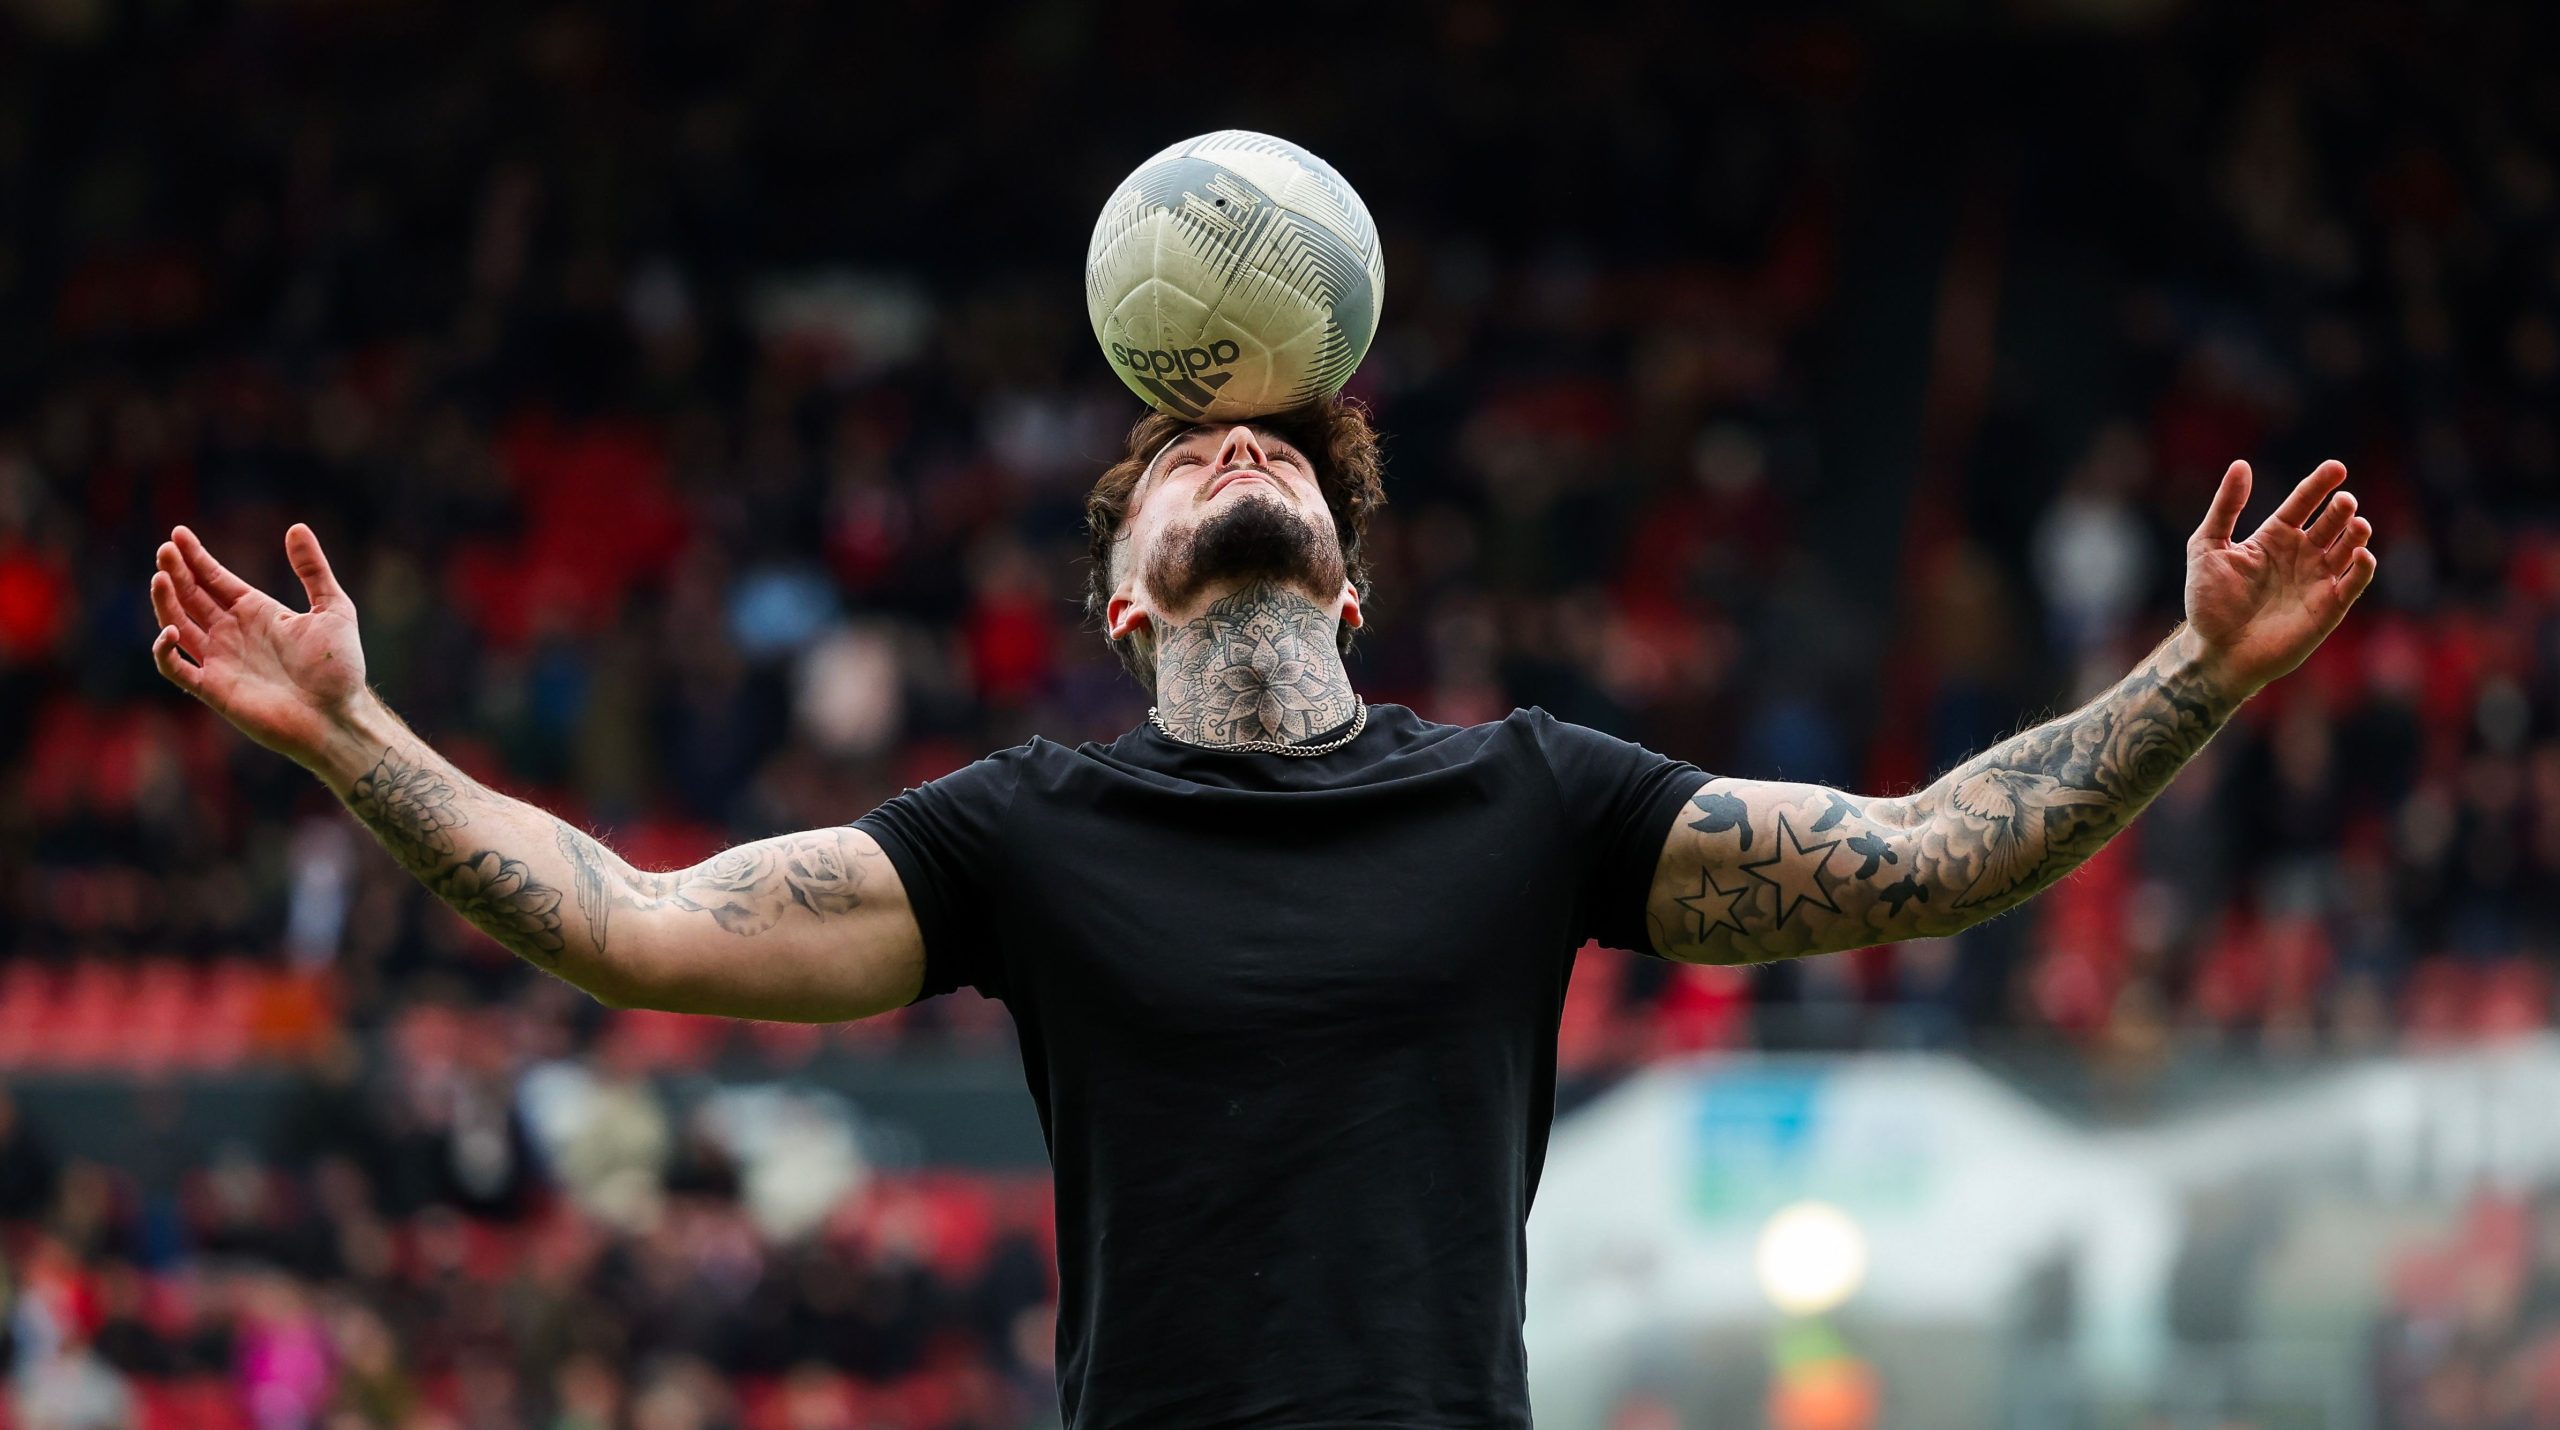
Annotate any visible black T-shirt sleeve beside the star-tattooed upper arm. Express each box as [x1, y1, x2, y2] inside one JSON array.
[[1528, 711, 1708, 954]]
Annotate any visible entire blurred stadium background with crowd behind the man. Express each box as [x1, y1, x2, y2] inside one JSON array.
[[0, 0, 2560, 1430]]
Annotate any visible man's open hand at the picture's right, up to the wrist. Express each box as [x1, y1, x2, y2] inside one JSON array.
[[2186, 460, 2376, 688]]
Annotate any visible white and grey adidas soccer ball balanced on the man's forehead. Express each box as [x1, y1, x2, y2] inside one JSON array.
[[1085, 128, 1388, 422]]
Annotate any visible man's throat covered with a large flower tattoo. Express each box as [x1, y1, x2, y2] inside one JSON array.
[[1155, 581, 1359, 744]]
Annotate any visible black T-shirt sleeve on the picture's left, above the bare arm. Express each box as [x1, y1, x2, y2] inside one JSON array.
[[852, 750, 1019, 1003]]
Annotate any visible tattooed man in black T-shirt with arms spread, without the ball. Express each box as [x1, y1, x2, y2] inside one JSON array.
[[151, 402, 2373, 1430]]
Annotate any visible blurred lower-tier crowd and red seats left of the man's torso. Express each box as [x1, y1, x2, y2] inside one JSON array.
[[0, 1013, 1057, 1430]]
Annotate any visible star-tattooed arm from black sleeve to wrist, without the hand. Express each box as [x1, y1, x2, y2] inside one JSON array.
[[1646, 640, 2240, 962]]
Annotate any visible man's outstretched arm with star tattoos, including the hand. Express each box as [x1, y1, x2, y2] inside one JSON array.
[[1646, 463, 2376, 964]]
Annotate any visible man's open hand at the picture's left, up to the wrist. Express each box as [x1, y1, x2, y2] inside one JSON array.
[[151, 522, 369, 767]]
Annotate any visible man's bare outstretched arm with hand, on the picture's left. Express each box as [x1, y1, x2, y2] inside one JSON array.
[[151, 524, 924, 1023]]
